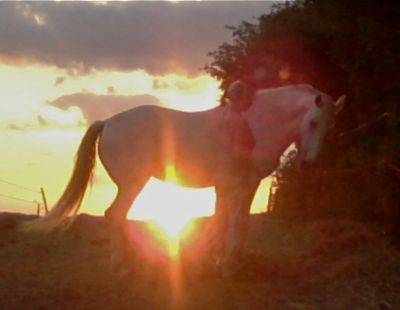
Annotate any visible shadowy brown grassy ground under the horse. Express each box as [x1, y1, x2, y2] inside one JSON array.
[[0, 213, 400, 310]]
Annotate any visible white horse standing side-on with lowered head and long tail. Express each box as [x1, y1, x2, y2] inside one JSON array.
[[26, 83, 345, 276]]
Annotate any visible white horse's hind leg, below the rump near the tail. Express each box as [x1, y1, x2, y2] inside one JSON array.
[[105, 182, 145, 276]]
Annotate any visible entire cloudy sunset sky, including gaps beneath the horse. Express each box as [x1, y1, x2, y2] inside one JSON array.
[[0, 1, 272, 224]]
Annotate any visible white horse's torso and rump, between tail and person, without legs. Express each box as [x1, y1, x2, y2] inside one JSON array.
[[95, 106, 220, 186]]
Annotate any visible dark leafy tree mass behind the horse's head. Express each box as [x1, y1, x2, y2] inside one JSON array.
[[205, 0, 400, 231]]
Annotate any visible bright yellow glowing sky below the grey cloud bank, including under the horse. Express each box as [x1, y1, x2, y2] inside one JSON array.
[[0, 65, 267, 220]]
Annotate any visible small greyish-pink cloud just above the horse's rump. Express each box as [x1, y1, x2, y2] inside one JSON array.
[[50, 93, 161, 123]]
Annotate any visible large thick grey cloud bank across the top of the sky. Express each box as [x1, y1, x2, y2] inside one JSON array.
[[0, 1, 272, 74]]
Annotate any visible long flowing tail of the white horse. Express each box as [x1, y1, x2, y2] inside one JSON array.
[[23, 121, 104, 231]]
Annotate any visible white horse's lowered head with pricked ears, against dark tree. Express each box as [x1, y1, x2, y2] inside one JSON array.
[[299, 95, 346, 166]]
